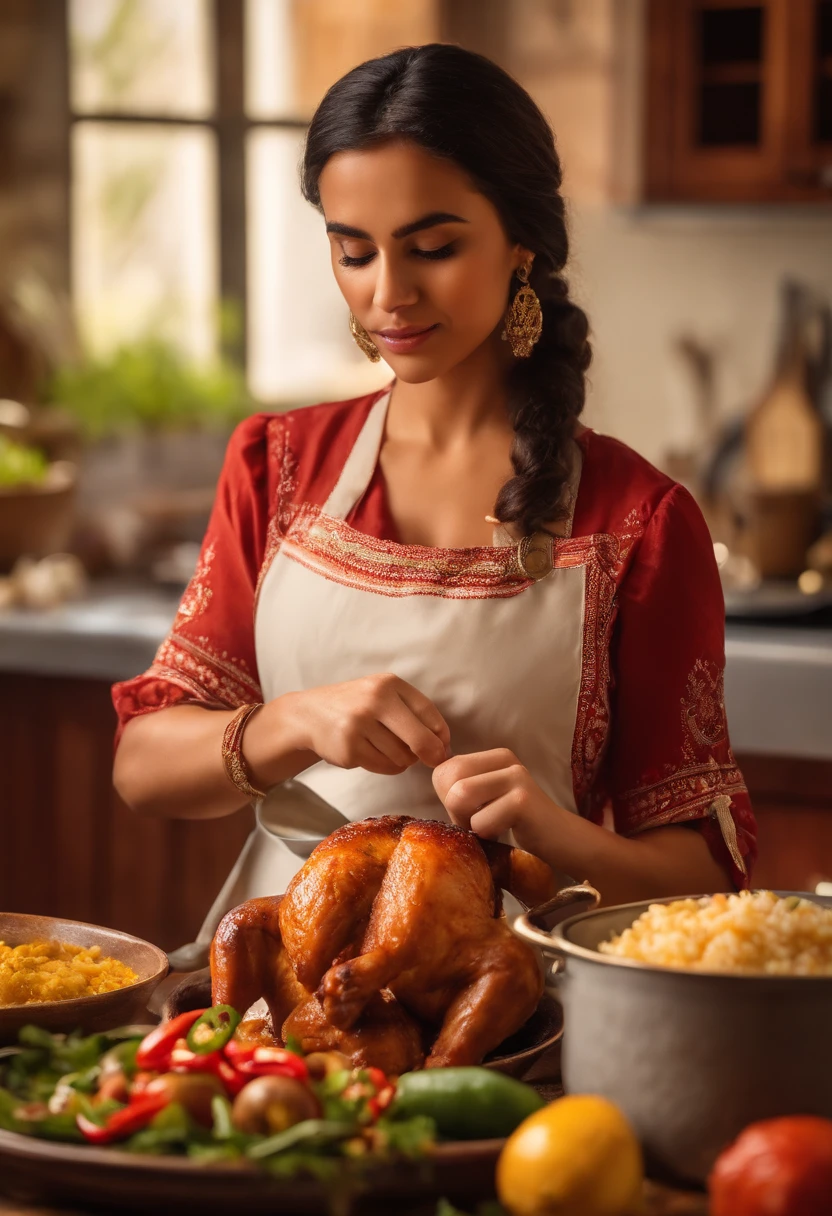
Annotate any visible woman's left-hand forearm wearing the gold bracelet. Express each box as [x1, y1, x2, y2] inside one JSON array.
[[113, 698, 317, 820]]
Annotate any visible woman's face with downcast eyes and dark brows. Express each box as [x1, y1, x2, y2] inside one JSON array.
[[320, 142, 530, 383]]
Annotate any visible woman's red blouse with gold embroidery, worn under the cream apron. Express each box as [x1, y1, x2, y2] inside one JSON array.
[[113, 394, 757, 886]]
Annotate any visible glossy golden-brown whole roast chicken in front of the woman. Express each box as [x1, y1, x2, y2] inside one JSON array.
[[210, 816, 555, 1074]]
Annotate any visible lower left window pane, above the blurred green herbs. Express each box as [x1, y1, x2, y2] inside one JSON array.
[[72, 122, 218, 359]]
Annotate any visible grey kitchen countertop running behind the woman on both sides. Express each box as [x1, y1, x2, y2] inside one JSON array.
[[0, 582, 832, 760]]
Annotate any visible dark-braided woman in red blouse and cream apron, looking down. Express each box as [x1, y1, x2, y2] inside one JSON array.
[[114, 45, 754, 919]]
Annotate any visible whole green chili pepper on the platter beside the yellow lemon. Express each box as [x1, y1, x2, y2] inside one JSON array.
[[388, 1068, 544, 1139]]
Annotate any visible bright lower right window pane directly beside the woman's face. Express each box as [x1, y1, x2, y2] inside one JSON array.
[[247, 130, 390, 402]]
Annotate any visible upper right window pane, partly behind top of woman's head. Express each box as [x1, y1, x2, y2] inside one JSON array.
[[246, 0, 439, 118]]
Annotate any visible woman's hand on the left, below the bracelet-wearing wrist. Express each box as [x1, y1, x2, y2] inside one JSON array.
[[251, 674, 450, 776]]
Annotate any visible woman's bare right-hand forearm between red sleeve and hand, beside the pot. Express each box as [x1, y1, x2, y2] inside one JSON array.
[[544, 811, 733, 905]]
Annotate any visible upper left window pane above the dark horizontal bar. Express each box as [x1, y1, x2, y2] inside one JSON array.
[[69, 0, 213, 118]]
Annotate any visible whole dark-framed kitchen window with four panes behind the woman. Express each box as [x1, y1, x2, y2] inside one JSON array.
[[68, 0, 439, 404]]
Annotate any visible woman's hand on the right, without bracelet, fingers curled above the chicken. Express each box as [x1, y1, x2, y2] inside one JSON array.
[[433, 748, 568, 860]]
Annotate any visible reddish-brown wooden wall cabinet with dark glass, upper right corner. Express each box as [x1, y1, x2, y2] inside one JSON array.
[[645, 0, 832, 202]]
